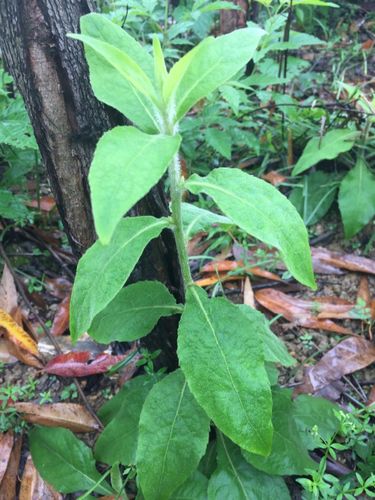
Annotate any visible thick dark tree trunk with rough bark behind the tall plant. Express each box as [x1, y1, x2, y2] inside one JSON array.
[[0, 0, 183, 367]]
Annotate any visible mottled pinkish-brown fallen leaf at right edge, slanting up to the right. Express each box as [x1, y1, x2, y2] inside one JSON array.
[[295, 337, 375, 393]]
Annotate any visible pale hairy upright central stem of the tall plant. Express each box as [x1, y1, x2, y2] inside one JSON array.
[[169, 153, 193, 290]]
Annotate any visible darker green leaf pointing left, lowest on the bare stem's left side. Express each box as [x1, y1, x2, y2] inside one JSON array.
[[89, 281, 182, 344]]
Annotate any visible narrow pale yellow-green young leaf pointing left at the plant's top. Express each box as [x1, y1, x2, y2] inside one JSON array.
[[69, 34, 158, 104]]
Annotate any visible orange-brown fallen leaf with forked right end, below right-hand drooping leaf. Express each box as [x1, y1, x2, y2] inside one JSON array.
[[255, 288, 353, 335]]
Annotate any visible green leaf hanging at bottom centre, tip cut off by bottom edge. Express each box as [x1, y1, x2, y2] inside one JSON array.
[[137, 370, 210, 500]]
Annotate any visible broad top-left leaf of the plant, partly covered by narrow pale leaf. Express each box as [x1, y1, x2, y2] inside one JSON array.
[[76, 13, 159, 132]]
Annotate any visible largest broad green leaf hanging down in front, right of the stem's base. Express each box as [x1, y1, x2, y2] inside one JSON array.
[[178, 286, 272, 455]]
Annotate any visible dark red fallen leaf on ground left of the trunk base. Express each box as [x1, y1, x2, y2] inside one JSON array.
[[43, 351, 127, 377]]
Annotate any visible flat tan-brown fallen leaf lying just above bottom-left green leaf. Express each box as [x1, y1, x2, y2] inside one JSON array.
[[13, 402, 99, 432]]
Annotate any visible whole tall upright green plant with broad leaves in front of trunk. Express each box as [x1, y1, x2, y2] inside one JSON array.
[[30, 14, 356, 499]]
